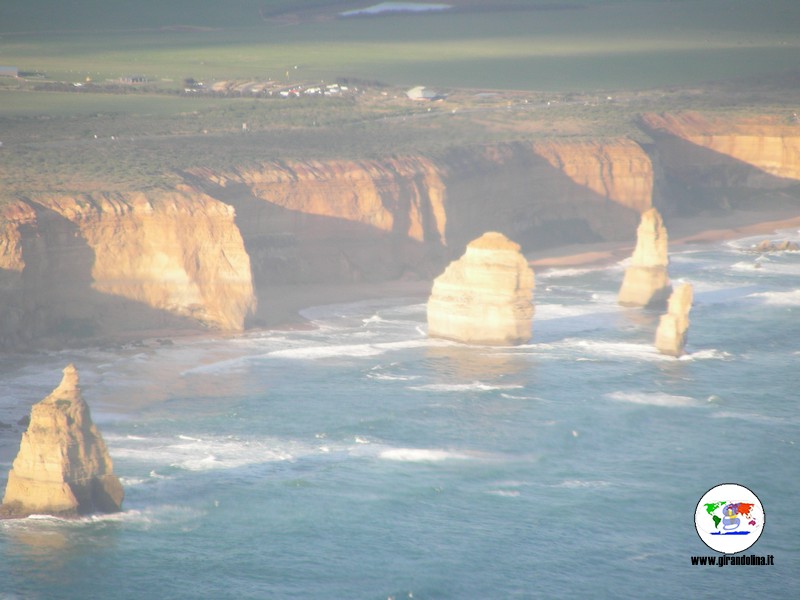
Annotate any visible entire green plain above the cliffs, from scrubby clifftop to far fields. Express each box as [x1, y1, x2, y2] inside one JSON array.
[[0, 0, 800, 203]]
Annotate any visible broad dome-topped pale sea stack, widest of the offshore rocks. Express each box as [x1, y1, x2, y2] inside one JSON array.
[[428, 231, 534, 346]]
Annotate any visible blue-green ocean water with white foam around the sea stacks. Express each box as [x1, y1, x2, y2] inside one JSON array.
[[0, 231, 800, 600]]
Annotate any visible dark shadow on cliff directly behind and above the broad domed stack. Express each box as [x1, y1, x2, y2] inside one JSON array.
[[442, 143, 639, 256]]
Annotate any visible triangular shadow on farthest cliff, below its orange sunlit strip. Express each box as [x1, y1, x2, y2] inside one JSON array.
[[639, 120, 800, 217]]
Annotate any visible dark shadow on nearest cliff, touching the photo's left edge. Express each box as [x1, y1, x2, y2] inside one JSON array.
[[0, 202, 200, 350]]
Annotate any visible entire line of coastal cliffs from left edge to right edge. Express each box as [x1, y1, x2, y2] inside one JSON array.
[[0, 113, 800, 349]]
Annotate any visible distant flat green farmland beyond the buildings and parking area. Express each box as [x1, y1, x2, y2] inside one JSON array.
[[0, 0, 800, 91]]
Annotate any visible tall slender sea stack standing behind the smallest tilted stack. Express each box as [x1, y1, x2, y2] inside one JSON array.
[[618, 208, 670, 306]]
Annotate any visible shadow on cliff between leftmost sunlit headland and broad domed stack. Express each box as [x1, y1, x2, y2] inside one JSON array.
[[189, 173, 444, 326]]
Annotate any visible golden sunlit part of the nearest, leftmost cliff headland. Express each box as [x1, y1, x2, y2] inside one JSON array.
[[36, 186, 255, 330]]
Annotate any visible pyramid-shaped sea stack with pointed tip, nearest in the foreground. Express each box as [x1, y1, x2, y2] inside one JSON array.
[[0, 364, 123, 517]]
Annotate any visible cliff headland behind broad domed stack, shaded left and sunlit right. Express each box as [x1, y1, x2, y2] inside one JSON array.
[[442, 139, 654, 256]]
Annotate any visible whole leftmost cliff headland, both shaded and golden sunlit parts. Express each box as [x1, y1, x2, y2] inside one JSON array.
[[0, 186, 255, 348]]
